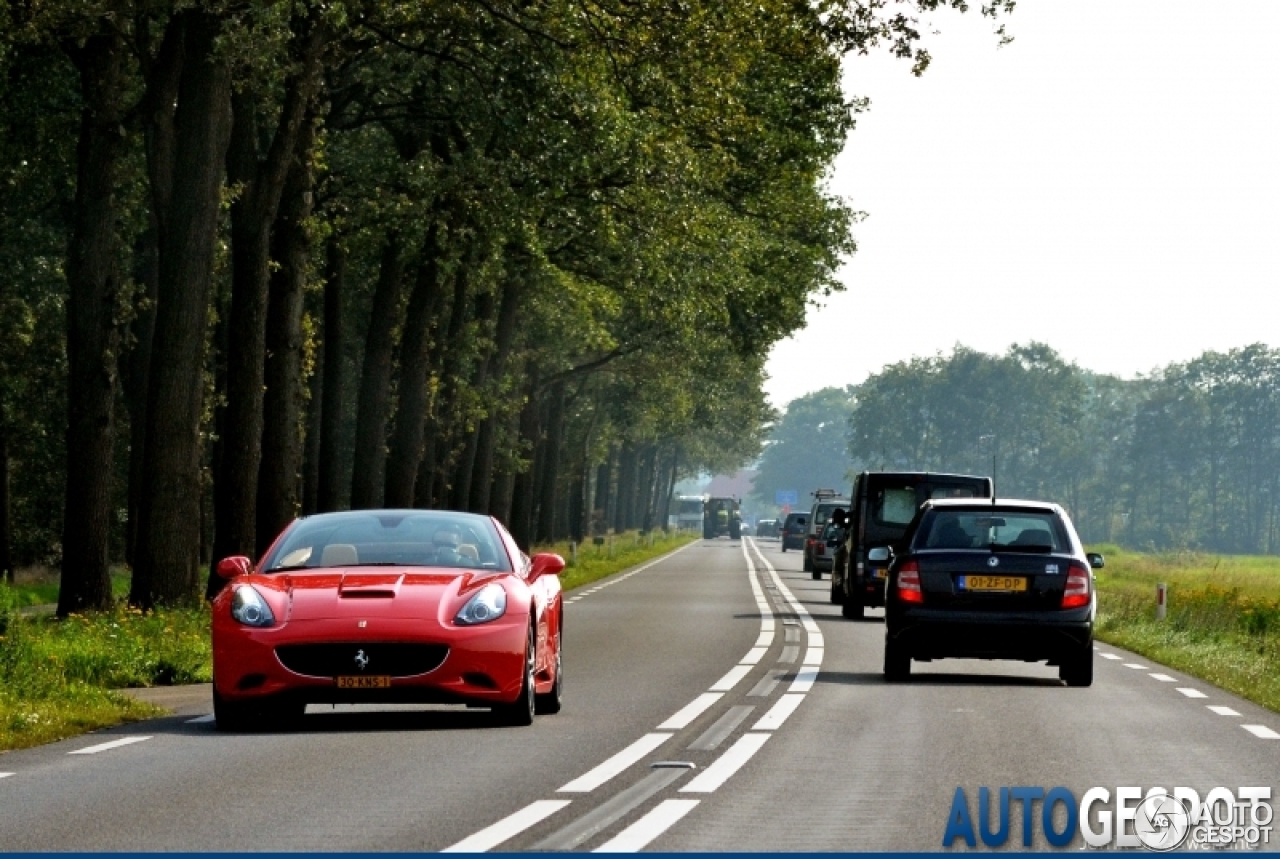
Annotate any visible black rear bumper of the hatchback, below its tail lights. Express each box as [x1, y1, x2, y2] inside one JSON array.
[[886, 607, 1093, 663]]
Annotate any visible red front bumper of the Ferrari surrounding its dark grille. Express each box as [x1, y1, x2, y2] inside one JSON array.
[[214, 616, 529, 705]]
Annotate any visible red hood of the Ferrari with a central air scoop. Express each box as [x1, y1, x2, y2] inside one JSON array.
[[255, 567, 502, 621]]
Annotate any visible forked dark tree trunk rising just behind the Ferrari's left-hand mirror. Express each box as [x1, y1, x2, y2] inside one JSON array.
[[210, 15, 325, 570]]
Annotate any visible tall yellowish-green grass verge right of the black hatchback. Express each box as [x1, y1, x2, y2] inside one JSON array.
[[1091, 545, 1280, 712]]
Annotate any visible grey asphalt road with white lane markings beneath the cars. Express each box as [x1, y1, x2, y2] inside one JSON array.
[[0, 539, 1280, 851]]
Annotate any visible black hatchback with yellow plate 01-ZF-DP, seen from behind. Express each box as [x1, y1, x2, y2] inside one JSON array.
[[868, 499, 1103, 686]]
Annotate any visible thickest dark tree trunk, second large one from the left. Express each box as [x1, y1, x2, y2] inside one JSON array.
[[129, 9, 230, 608]]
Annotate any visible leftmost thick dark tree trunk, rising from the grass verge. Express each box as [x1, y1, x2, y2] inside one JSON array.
[[58, 33, 125, 617]]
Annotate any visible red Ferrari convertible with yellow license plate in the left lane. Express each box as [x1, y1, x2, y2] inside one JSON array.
[[212, 510, 564, 731]]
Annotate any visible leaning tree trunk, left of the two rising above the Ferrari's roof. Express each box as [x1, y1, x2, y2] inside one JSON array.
[[351, 233, 404, 510]]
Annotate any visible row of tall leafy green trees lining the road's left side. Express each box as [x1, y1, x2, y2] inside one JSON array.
[[0, 0, 1011, 613]]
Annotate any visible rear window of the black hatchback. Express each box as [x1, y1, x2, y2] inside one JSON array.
[[915, 510, 1070, 552]]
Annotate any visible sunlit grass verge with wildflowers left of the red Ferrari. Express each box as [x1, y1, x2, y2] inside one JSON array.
[[0, 586, 211, 750]]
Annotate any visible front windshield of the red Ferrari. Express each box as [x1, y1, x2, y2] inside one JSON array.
[[262, 511, 511, 572]]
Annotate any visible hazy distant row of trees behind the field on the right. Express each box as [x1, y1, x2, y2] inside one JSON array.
[[758, 343, 1280, 553]]
